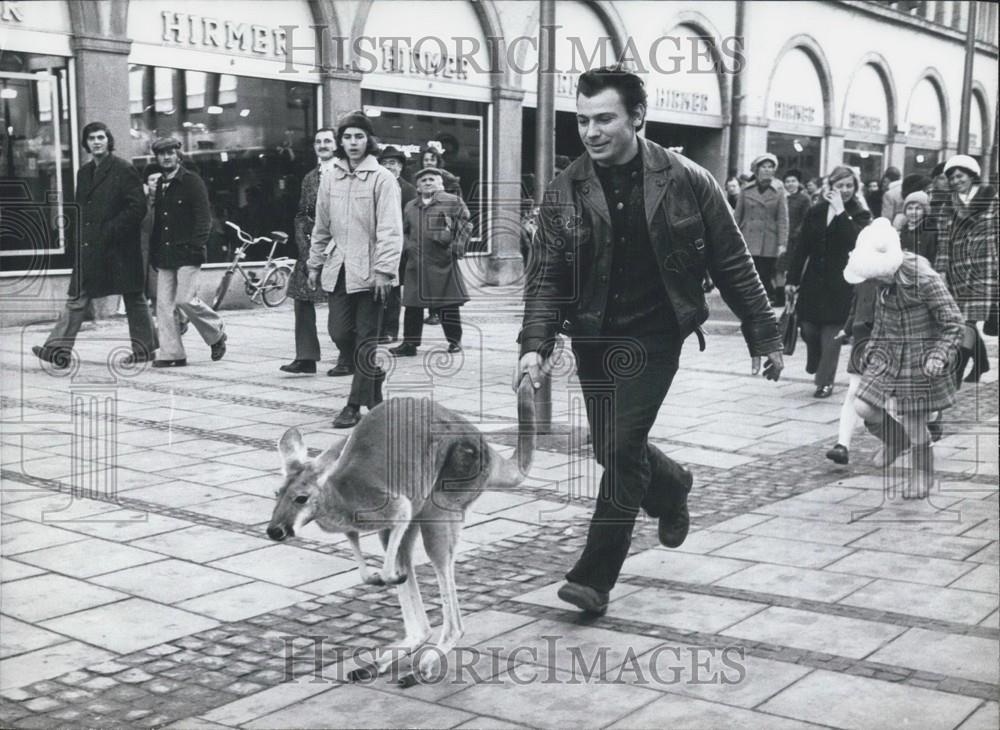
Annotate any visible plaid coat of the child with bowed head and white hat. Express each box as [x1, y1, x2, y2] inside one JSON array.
[[857, 253, 965, 413]]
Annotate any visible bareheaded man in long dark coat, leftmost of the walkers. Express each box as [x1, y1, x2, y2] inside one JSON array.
[[31, 122, 157, 368]]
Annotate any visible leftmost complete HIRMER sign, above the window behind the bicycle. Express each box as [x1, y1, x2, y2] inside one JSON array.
[[161, 10, 285, 57]]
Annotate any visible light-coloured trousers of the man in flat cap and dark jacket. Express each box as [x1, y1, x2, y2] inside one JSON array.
[[156, 266, 225, 360]]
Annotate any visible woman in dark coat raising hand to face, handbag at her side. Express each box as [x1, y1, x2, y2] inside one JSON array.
[[786, 167, 872, 398]]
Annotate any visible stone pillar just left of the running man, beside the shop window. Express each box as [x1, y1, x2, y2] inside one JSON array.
[[476, 88, 526, 286]]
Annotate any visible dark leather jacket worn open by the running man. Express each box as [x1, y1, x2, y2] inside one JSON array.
[[518, 138, 782, 356]]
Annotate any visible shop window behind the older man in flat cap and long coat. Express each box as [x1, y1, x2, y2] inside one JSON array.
[[361, 89, 490, 255]]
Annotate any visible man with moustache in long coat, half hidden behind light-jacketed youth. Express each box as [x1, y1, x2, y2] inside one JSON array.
[[279, 127, 342, 376]]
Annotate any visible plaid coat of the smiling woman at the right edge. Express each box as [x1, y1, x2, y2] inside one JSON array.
[[934, 185, 1000, 322]]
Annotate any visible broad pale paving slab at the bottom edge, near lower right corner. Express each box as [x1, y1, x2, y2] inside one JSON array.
[[757, 670, 980, 730]]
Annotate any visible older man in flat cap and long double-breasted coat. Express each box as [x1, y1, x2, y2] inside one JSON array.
[[389, 167, 470, 357]]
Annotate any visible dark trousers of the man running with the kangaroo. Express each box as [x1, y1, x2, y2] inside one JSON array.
[[566, 342, 686, 591]]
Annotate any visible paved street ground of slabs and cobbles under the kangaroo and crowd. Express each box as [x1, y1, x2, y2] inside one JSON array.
[[0, 301, 1000, 730]]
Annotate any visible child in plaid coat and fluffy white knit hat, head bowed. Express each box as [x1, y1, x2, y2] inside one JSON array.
[[844, 218, 963, 499]]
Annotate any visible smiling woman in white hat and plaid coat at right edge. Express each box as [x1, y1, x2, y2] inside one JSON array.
[[934, 155, 1000, 383]]
